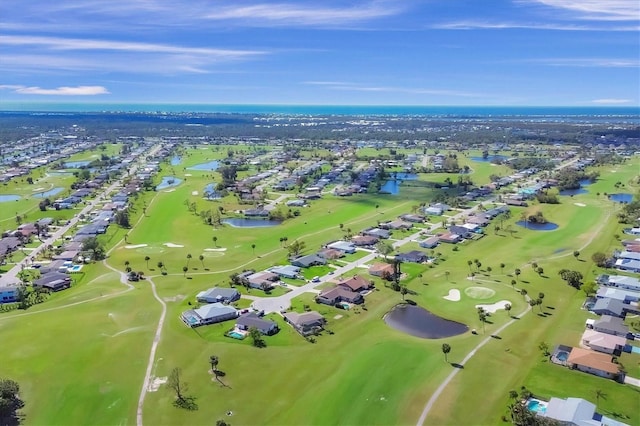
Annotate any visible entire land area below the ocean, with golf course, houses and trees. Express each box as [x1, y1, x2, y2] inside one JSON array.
[[0, 112, 640, 426]]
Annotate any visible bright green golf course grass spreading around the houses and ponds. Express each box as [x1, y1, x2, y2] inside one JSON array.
[[0, 146, 640, 425]]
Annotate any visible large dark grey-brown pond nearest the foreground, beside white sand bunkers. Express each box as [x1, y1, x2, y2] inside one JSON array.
[[384, 304, 469, 339]]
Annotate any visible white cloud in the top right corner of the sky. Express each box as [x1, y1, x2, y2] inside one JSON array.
[[520, 0, 640, 21]]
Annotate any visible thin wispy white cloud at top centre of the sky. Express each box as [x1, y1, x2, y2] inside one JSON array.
[[206, 2, 400, 26]]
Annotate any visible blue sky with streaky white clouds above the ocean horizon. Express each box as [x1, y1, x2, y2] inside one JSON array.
[[0, 0, 640, 106]]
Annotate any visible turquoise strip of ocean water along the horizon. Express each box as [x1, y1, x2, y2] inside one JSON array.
[[0, 102, 640, 122]]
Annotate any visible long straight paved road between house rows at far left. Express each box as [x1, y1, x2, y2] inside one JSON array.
[[0, 145, 160, 286]]
